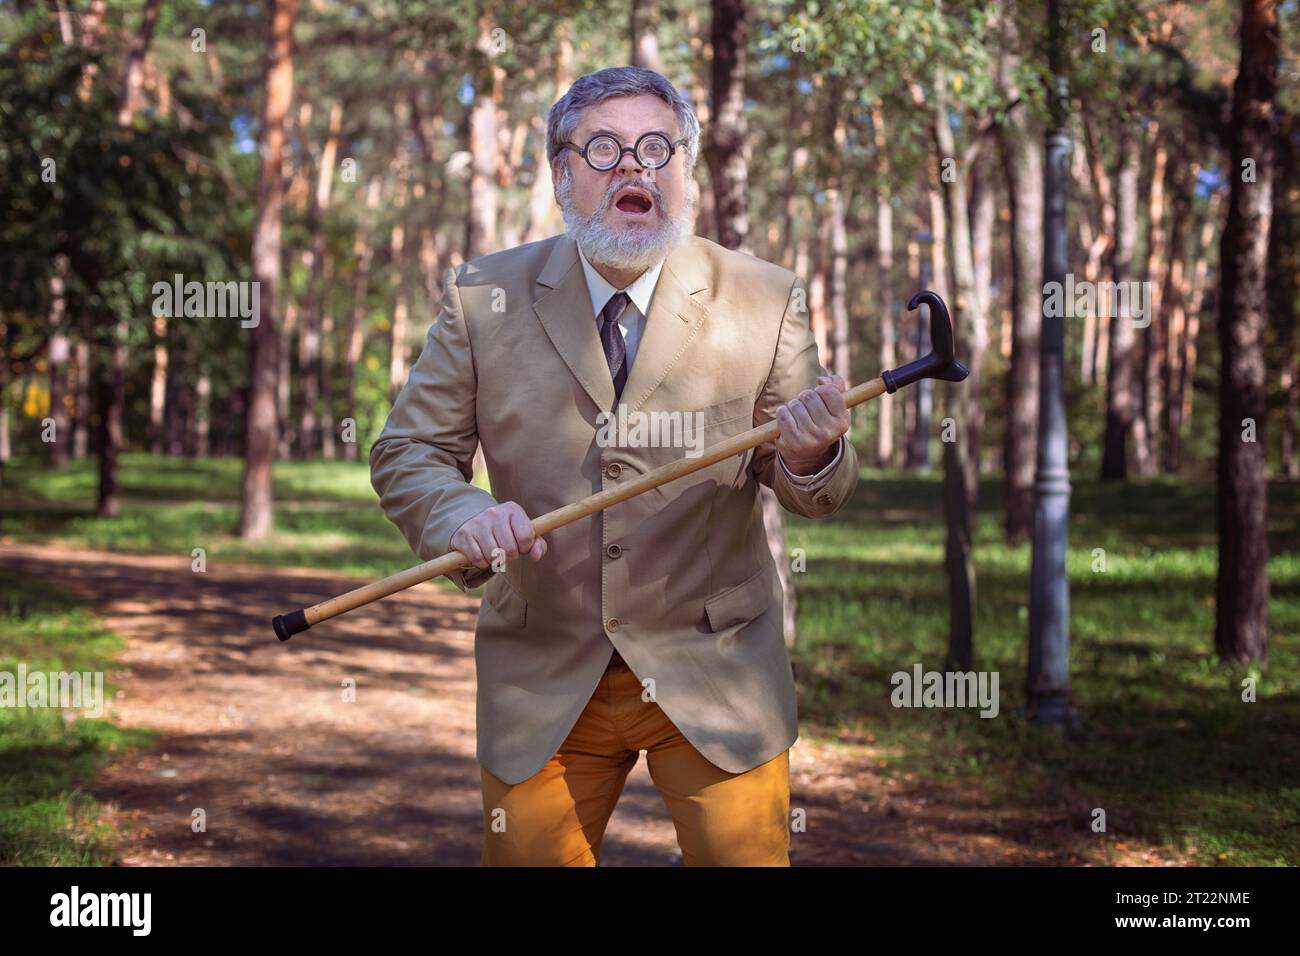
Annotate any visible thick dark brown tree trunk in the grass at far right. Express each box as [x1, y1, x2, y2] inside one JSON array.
[[1214, 0, 1279, 662]]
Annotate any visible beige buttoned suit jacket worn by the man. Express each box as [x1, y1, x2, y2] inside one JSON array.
[[371, 235, 858, 783]]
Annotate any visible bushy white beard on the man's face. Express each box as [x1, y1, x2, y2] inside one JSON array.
[[555, 169, 694, 271]]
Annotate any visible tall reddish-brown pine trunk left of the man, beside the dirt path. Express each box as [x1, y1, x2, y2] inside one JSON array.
[[239, 0, 298, 540]]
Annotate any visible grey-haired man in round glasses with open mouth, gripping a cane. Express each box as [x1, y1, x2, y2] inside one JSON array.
[[371, 66, 858, 866]]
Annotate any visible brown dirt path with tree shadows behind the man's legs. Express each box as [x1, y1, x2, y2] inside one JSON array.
[[0, 542, 1171, 866]]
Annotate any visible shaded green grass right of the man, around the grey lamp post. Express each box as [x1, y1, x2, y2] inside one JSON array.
[[788, 472, 1300, 865]]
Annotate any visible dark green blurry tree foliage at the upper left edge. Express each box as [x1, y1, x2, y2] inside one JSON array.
[[0, 1, 250, 429]]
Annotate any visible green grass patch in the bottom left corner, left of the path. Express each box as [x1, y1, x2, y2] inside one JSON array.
[[0, 579, 152, 866]]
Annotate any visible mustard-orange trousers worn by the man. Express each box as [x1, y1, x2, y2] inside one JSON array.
[[480, 653, 790, 866]]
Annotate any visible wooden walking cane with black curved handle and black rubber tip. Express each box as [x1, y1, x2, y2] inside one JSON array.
[[270, 290, 970, 641]]
